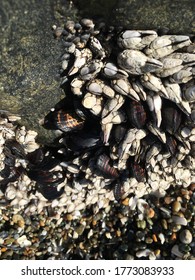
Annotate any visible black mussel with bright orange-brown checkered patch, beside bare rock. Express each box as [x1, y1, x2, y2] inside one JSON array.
[[43, 109, 84, 132]]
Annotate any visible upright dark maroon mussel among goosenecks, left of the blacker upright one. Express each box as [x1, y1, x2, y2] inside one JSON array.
[[126, 99, 147, 129]]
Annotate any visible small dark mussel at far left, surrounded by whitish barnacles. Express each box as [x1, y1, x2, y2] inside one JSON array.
[[4, 139, 26, 159]]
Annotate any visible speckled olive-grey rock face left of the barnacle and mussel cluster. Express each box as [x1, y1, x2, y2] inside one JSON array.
[[0, 0, 78, 142]]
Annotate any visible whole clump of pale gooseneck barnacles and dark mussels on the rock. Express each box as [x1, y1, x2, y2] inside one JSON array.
[[0, 19, 195, 203]]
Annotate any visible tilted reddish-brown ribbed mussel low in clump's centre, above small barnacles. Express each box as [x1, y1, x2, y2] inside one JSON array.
[[96, 154, 119, 178]]
